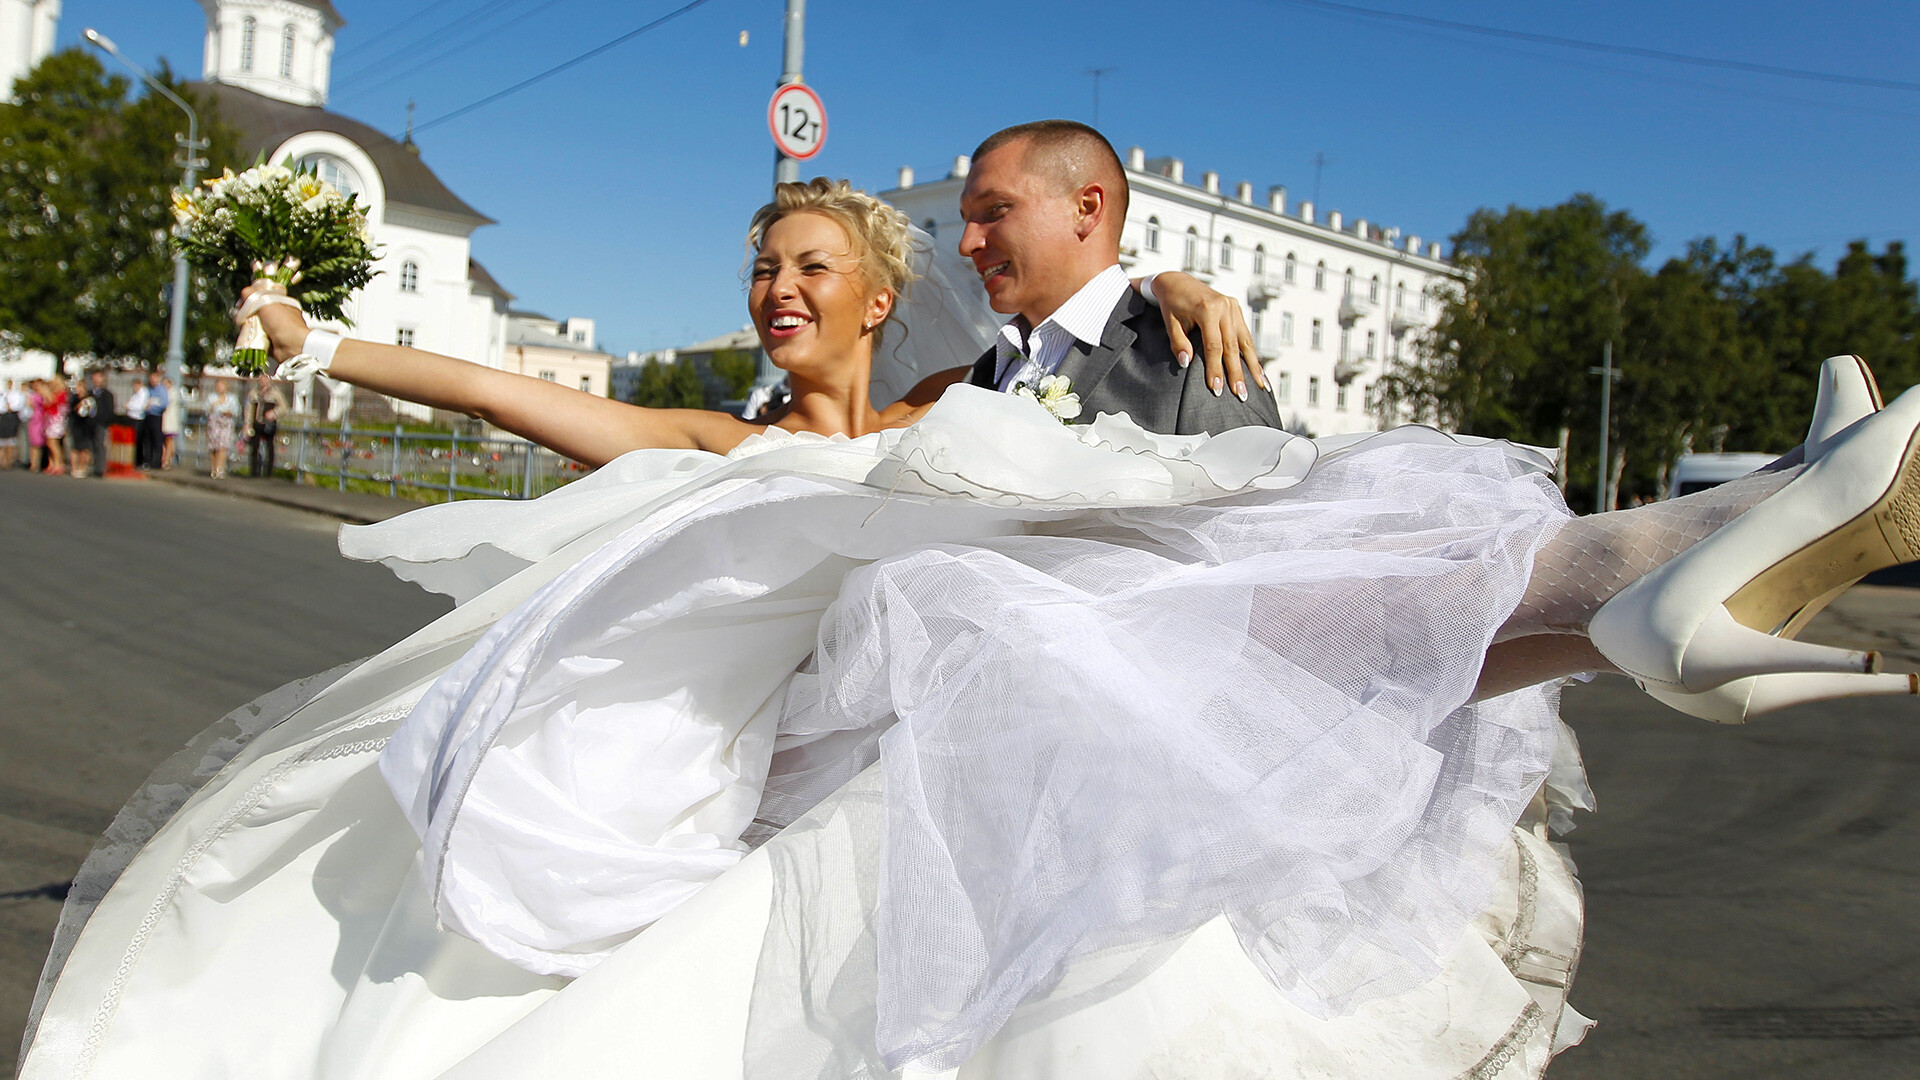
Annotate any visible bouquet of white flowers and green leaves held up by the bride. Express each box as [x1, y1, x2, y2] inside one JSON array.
[[173, 165, 376, 375]]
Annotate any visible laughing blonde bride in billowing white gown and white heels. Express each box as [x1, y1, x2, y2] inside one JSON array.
[[21, 183, 1920, 1078]]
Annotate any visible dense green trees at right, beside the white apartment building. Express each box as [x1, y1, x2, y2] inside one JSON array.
[[1380, 194, 1920, 507]]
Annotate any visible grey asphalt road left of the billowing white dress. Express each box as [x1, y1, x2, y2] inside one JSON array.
[[0, 471, 449, 1076]]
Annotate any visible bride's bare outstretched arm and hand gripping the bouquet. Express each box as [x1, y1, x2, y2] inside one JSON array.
[[242, 288, 755, 465]]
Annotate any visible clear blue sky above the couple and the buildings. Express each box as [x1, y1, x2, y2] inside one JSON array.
[[60, 0, 1920, 352]]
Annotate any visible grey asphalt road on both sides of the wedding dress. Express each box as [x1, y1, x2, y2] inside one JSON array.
[[0, 473, 1920, 1080]]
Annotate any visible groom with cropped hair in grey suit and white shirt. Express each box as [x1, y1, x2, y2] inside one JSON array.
[[908, 119, 1281, 434]]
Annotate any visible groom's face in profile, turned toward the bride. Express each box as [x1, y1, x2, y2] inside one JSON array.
[[960, 138, 1081, 323]]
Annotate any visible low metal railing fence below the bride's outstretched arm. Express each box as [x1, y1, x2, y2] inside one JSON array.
[[180, 417, 588, 502]]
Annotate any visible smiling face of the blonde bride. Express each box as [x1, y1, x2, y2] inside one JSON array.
[[747, 209, 893, 375]]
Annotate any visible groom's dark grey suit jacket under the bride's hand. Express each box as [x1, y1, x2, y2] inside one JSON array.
[[968, 288, 1281, 434]]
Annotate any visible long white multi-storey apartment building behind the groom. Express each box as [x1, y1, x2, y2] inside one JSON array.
[[879, 146, 1461, 434]]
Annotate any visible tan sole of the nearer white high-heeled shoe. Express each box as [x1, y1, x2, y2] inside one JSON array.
[[1726, 422, 1920, 638]]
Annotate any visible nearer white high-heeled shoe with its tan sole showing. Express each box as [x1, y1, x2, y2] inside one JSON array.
[[1588, 355, 1920, 687]]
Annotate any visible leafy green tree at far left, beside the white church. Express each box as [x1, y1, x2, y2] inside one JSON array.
[[0, 50, 236, 365]]
